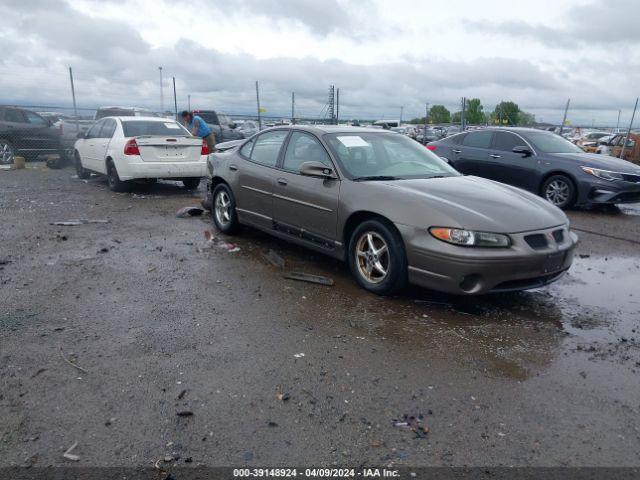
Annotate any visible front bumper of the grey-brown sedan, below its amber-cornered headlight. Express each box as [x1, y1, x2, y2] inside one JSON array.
[[398, 225, 578, 295]]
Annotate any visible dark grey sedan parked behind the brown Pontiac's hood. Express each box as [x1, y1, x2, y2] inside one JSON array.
[[427, 128, 640, 208]]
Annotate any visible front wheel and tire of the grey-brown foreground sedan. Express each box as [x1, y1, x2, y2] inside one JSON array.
[[348, 219, 407, 295]]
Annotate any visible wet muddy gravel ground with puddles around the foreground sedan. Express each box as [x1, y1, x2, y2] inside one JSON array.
[[0, 166, 640, 466]]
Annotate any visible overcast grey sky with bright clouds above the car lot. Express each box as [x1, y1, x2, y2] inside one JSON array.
[[0, 0, 640, 125]]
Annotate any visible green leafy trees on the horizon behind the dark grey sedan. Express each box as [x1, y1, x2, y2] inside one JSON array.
[[409, 98, 536, 126]]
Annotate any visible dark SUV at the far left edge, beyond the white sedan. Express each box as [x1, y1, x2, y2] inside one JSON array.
[[0, 106, 64, 165]]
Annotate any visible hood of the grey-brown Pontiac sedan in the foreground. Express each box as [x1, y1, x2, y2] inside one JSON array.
[[372, 176, 568, 233]]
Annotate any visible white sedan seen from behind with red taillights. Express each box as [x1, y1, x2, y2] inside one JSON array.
[[74, 117, 209, 192]]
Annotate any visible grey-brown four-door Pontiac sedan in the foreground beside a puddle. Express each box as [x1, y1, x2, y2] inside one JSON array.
[[208, 126, 577, 295]]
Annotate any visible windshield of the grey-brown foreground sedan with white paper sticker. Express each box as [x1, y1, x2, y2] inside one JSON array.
[[325, 132, 459, 180]]
